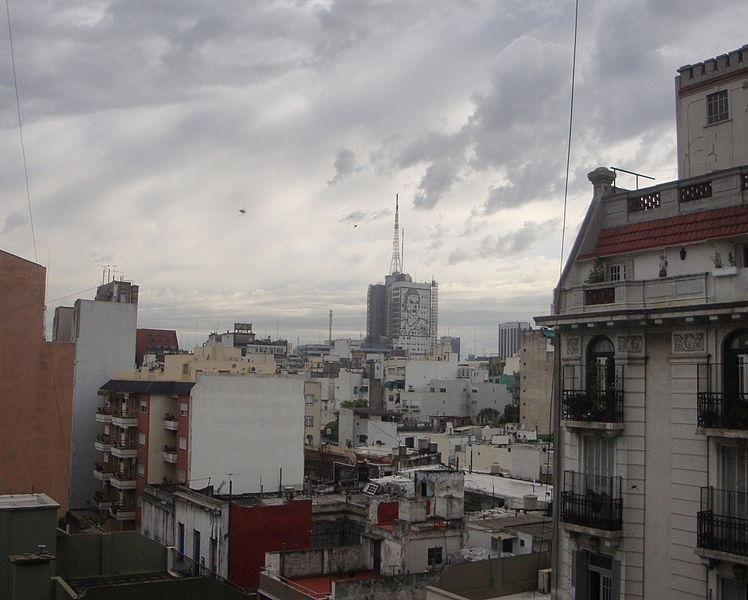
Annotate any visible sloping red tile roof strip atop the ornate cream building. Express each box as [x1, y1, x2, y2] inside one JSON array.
[[578, 205, 748, 258]]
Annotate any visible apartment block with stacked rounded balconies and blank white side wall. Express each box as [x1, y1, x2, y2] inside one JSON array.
[[93, 374, 305, 529]]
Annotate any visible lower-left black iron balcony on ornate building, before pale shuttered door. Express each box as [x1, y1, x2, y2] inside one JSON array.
[[561, 471, 623, 535]]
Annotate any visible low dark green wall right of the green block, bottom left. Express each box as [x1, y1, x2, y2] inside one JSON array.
[[57, 531, 166, 579]]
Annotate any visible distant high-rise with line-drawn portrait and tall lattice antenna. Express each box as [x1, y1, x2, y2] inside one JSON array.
[[366, 200, 439, 355]]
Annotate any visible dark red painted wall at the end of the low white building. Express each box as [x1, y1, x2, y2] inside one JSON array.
[[229, 500, 312, 589]]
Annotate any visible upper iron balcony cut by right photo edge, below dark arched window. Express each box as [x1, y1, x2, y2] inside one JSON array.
[[696, 363, 748, 437]]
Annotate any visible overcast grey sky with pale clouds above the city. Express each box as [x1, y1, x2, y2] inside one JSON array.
[[0, 0, 748, 353]]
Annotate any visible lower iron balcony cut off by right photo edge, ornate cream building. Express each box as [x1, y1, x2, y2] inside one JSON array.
[[696, 487, 748, 558]]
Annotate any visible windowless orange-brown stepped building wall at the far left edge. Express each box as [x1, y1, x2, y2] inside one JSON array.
[[0, 250, 75, 512]]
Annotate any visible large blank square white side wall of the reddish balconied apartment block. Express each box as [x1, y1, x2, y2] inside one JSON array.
[[189, 375, 304, 494]]
